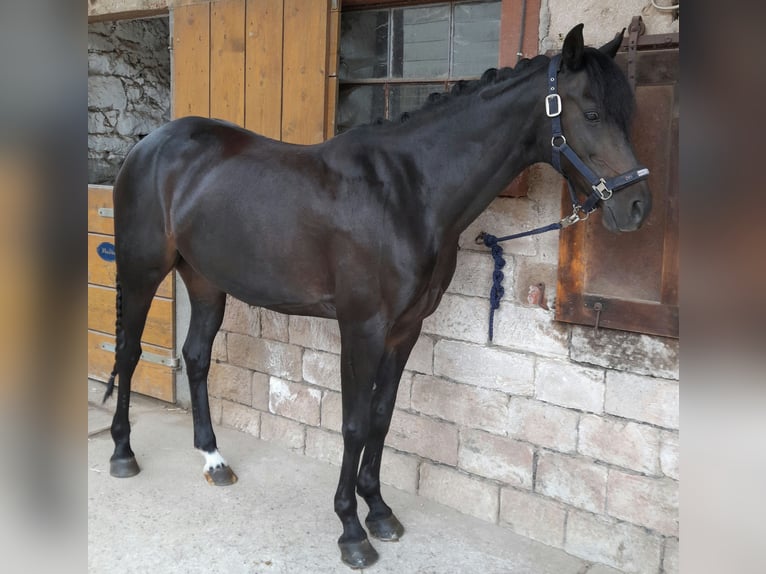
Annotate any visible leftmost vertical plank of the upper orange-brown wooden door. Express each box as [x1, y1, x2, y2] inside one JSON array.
[[172, 3, 210, 118]]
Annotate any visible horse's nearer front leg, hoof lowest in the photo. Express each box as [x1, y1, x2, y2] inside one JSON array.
[[335, 321, 385, 568]]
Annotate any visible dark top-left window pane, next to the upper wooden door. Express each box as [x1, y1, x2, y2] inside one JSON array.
[[338, 10, 388, 80]]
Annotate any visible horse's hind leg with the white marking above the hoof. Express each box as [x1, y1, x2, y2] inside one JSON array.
[[178, 259, 237, 486]]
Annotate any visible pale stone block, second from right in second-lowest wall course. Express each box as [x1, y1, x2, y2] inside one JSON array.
[[535, 452, 607, 513]]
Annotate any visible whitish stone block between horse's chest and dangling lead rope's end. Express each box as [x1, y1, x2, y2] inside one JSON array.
[[423, 293, 489, 345]]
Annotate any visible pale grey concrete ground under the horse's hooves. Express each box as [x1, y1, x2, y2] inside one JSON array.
[[88, 381, 616, 574]]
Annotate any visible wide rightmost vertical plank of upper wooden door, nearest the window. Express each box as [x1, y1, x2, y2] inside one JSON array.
[[282, 0, 330, 144]]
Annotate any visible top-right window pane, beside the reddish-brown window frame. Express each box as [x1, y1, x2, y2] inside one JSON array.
[[451, 2, 501, 78]]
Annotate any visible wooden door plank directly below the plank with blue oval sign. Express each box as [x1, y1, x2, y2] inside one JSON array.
[[88, 285, 174, 349]]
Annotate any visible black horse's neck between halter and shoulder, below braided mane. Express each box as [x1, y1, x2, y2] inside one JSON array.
[[414, 68, 550, 235]]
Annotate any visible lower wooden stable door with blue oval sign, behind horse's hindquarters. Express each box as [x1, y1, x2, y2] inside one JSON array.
[[88, 185, 178, 402]]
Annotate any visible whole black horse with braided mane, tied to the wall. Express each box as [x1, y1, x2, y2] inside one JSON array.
[[105, 25, 651, 568]]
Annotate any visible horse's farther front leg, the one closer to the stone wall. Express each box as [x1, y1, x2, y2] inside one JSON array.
[[357, 322, 422, 541]]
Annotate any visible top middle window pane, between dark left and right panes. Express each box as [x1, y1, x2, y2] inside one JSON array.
[[391, 6, 450, 78]]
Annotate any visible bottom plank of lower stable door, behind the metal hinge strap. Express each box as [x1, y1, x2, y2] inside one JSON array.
[[88, 331, 175, 403]]
